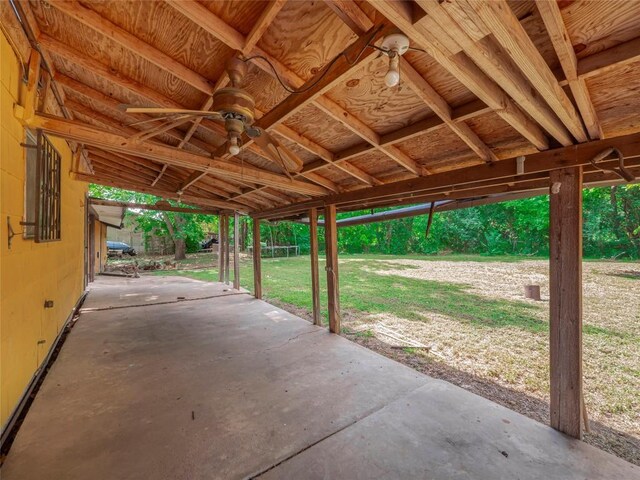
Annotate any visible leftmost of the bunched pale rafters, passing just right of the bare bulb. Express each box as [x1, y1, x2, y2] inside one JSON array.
[[368, 0, 549, 150]]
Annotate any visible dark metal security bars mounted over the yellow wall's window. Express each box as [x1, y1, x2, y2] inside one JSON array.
[[35, 130, 61, 243]]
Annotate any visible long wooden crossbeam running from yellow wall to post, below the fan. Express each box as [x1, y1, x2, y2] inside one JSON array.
[[29, 115, 327, 195]]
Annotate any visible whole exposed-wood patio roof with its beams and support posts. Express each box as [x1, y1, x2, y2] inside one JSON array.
[[0, 0, 640, 458]]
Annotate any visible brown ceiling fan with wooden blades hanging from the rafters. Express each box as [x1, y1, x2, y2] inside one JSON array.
[[125, 55, 302, 174]]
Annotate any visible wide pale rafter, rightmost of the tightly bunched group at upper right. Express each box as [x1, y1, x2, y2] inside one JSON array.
[[465, 0, 588, 142]]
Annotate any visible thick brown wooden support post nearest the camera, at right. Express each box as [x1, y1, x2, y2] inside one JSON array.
[[549, 167, 582, 438]]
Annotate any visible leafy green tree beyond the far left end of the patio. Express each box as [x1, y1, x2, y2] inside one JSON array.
[[89, 184, 217, 260]]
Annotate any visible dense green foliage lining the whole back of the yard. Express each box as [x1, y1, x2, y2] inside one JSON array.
[[91, 185, 640, 259]]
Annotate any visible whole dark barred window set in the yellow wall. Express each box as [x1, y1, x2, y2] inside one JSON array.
[[24, 131, 61, 243]]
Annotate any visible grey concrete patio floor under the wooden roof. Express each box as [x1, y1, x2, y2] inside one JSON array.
[[0, 277, 640, 480]]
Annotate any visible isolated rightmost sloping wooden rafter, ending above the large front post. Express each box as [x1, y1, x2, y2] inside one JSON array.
[[536, 0, 604, 140]]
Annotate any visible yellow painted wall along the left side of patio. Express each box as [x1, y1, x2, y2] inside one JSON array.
[[0, 33, 87, 432]]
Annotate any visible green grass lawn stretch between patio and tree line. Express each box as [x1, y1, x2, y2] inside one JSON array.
[[155, 255, 616, 334]]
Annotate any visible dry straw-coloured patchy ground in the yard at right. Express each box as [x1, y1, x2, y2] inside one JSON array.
[[345, 259, 640, 465]]
